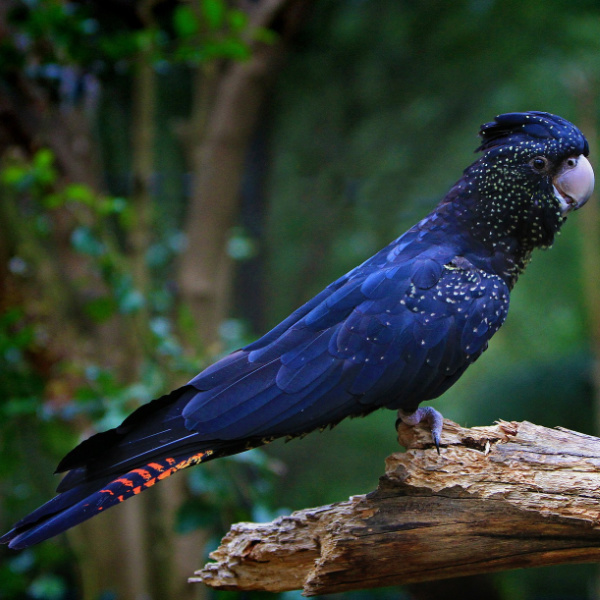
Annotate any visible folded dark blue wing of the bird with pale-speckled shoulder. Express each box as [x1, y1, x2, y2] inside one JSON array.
[[183, 247, 508, 440]]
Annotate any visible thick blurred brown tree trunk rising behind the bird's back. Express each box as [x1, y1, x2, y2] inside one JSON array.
[[178, 0, 306, 351]]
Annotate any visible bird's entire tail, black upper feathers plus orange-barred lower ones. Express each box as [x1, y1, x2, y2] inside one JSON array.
[[0, 386, 265, 549]]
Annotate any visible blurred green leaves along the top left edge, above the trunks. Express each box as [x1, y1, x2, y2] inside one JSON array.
[[0, 0, 277, 81]]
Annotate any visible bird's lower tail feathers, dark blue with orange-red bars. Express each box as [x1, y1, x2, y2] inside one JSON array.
[[0, 449, 217, 550]]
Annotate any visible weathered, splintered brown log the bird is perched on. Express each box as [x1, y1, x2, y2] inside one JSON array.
[[196, 421, 600, 596]]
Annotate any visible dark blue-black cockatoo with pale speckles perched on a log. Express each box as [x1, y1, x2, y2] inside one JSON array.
[[0, 111, 594, 549]]
